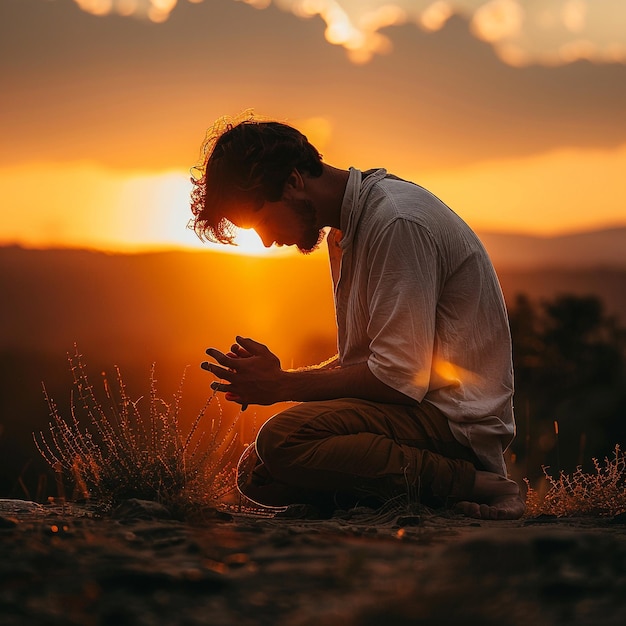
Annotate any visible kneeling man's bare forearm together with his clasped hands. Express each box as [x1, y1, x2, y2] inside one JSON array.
[[202, 337, 416, 405]]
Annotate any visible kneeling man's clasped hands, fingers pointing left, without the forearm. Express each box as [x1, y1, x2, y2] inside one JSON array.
[[200, 336, 285, 411]]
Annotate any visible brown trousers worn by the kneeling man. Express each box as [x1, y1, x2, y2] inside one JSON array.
[[237, 398, 482, 506]]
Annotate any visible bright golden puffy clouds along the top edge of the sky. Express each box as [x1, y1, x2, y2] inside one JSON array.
[[68, 0, 626, 66]]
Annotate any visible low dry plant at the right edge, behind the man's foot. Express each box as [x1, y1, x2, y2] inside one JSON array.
[[526, 445, 626, 517]]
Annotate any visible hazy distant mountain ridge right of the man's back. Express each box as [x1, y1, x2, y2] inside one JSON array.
[[478, 227, 626, 269]]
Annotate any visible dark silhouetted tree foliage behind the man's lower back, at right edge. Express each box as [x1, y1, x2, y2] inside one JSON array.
[[509, 294, 626, 479]]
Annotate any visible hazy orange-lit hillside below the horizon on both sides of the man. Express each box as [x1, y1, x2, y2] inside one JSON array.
[[0, 241, 626, 365]]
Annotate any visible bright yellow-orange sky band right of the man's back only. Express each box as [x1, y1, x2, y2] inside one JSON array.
[[412, 145, 626, 235]]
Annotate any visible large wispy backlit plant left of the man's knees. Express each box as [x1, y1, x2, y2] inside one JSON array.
[[34, 350, 238, 508]]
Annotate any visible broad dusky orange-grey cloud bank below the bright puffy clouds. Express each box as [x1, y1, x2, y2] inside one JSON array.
[[6, 0, 626, 175]]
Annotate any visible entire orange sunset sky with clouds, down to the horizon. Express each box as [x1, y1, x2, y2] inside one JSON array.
[[0, 0, 626, 250]]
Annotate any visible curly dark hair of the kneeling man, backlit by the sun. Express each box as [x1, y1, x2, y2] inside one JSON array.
[[189, 111, 323, 244]]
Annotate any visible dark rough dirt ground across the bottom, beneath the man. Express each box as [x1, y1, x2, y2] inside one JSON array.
[[0, 500, 626, 626]]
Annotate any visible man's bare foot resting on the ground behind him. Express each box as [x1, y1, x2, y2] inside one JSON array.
[[454, 471, 526, 520]]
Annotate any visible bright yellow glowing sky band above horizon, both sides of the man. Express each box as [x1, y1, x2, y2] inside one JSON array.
[[0, 145, 626, 256]]
